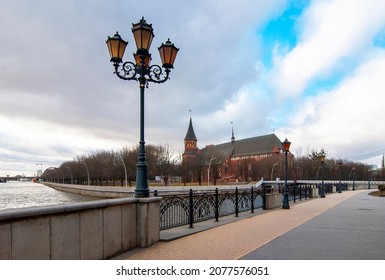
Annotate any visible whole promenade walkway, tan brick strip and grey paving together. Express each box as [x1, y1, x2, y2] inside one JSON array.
[[117, 190, 385, 260]]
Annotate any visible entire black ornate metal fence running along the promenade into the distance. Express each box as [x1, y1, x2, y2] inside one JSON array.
[[154, 183, 347, 230]]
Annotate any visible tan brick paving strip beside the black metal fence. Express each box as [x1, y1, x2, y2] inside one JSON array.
[[116, 190, 385, 260]]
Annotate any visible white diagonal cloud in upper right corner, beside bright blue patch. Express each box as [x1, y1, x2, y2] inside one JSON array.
[[270, 0, 385, 97]]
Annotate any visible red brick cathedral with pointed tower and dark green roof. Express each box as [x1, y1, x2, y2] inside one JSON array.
[[182, 118, 293, 182]]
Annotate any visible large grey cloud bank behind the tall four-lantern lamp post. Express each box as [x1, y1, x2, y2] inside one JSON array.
[[0, 0, 286, 175]]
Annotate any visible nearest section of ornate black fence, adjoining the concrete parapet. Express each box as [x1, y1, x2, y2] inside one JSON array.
[[155, 187, 264, 230]]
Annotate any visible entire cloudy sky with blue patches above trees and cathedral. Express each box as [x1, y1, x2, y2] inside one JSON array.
[[0, 0, 385, 176]]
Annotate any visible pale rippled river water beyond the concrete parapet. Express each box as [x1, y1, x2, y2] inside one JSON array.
[[0, 182, 100, 211]]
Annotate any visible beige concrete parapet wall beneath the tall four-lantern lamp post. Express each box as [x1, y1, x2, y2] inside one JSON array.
[[0, 198, 161, 260]]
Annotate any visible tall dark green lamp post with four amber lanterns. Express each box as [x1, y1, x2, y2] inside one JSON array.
[[106, 18, 179, 197]]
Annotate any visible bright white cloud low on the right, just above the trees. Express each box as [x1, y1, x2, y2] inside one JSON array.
[[280, 49, 385, 162]]
